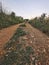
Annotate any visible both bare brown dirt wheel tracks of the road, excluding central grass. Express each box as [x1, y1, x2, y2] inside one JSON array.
[[0, 23, 49, 65]]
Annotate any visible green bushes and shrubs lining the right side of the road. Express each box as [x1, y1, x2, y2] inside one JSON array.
[[29, 13, 49, 36]]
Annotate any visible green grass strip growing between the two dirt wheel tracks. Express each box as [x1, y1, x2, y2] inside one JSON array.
[[1, 25, 35, 65]]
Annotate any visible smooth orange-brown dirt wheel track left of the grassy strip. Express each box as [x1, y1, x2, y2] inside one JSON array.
[[0, 24, 19, 51]]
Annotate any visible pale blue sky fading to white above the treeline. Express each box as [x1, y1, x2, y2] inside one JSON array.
[[0, 0, 49, 19]]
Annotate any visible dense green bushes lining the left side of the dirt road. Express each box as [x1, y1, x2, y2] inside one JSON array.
[[0, 12, 24, 29]]
